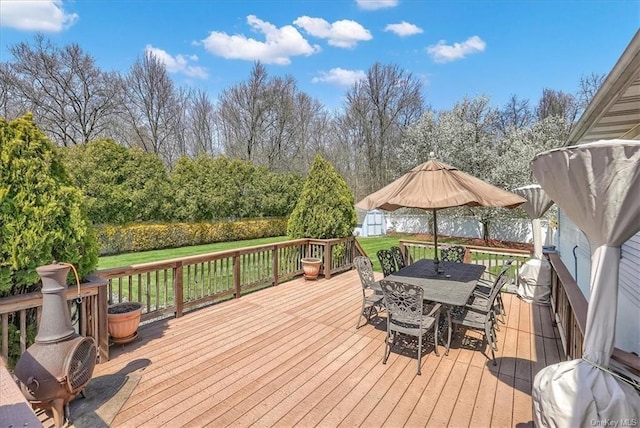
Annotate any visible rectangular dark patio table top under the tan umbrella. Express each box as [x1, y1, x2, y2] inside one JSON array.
[[384, 259, 485, 306]]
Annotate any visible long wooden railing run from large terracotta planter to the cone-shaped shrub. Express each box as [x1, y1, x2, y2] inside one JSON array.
[[95, 237, 355, 322]]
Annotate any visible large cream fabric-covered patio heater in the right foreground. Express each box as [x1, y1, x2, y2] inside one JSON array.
[[532, 140, 640, 426]]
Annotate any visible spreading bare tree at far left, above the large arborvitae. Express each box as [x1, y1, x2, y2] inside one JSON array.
[[3, 35, 116, 146]]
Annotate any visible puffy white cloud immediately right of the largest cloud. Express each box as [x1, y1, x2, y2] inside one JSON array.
[[293, 16, 373, 48]]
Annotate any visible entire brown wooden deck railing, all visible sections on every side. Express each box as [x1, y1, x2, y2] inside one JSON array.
[[5, 237, 640, 372]]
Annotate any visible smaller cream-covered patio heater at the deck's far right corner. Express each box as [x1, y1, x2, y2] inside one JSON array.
[[513, 184, 553, 304]]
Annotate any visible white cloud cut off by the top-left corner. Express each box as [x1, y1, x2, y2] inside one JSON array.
[[0, 0, 78, 33]]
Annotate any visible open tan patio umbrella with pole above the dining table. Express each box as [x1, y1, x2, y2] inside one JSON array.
[[356, 159, 526, 266]]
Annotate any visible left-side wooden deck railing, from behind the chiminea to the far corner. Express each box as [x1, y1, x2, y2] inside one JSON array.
[[0, 237, 362, 362]]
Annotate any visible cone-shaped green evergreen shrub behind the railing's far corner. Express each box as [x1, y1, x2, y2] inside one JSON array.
[[287, 156, 357, 239]]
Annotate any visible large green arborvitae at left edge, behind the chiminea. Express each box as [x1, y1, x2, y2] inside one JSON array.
[[0, 114, 98, 296]]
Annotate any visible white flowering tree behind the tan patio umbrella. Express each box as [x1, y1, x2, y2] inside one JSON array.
[[398, 96, 568, 239]]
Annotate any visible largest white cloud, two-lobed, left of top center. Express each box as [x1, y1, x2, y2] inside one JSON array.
[[202, 15, 320, 65]]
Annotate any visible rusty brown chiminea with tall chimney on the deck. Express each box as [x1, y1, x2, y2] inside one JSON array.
[[14, 263, 97, 427]]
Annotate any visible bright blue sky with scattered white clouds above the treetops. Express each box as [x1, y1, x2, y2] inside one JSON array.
[[0, 0, 640, 110]]
